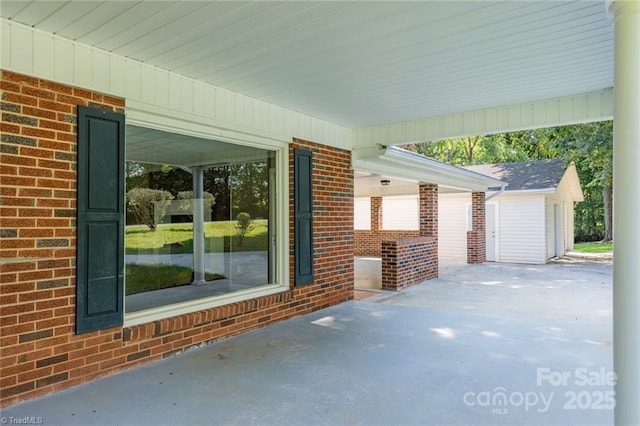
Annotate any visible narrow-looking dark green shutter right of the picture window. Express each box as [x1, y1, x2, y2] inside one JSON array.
[[293, 149, 313, 286]]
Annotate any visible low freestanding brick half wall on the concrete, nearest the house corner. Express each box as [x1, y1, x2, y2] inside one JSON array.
[[382, 237, 438, 291]]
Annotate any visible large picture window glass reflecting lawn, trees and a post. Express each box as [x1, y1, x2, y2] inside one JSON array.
[[124, 126, 277, 314]]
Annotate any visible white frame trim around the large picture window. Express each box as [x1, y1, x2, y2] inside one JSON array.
[[123, 109, 290, 327]]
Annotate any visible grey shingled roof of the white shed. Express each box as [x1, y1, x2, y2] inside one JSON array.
[[465, 158, 567, 191]]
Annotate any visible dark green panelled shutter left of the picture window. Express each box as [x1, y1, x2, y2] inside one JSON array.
[[76, 106, 125, 334]]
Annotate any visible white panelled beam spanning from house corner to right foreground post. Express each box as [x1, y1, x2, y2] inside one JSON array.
[[354, 89, 613, 149]]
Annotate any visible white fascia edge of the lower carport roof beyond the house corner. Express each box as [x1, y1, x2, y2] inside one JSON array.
[[353, 146, 506, 192]]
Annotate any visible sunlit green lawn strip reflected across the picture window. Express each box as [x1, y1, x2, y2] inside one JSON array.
[[125, 219, 268, 254]]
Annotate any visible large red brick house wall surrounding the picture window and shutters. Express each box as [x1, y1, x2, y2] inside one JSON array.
[[0, 71, 353, 406]]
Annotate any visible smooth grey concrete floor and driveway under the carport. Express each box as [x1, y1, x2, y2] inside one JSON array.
[[2, 263, 614, 425]]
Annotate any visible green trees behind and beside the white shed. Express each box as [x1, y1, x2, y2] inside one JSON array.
[[405, 121, 613, 241]]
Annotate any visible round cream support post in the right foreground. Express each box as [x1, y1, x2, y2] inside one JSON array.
[[610, 0, 640, 425]]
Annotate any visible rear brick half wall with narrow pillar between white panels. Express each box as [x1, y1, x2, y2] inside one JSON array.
[[354, 197, 420, 257]]
